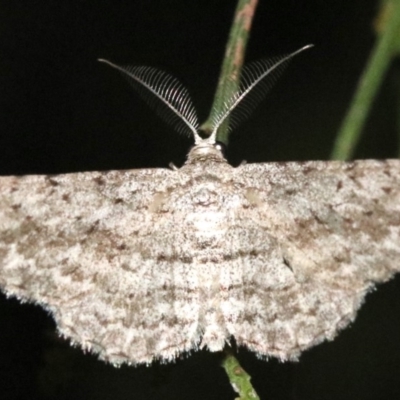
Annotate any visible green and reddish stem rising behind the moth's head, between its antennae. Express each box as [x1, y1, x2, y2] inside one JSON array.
[[200, 0, 258, 145]]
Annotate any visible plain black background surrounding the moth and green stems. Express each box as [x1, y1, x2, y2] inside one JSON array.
[[0, 0, 400, 400]]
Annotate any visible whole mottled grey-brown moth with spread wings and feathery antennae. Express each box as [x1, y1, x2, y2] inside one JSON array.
[[0, 46, 400, 365]]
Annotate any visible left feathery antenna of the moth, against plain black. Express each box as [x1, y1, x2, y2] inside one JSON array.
[[98, 58, 202, 143]]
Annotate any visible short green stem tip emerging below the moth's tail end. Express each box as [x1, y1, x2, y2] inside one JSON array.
[[222, 352, 260, 400]]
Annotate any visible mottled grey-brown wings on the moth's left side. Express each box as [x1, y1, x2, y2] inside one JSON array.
[[0, 169, 203, 363]]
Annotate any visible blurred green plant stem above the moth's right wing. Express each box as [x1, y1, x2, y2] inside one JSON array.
[[331, 0, 400, 160]]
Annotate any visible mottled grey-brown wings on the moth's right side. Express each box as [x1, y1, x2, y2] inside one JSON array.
[[229, 160, 400, 359]]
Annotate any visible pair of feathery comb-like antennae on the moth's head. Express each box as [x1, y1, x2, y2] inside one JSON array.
[[98, 45, 313, 144]]
